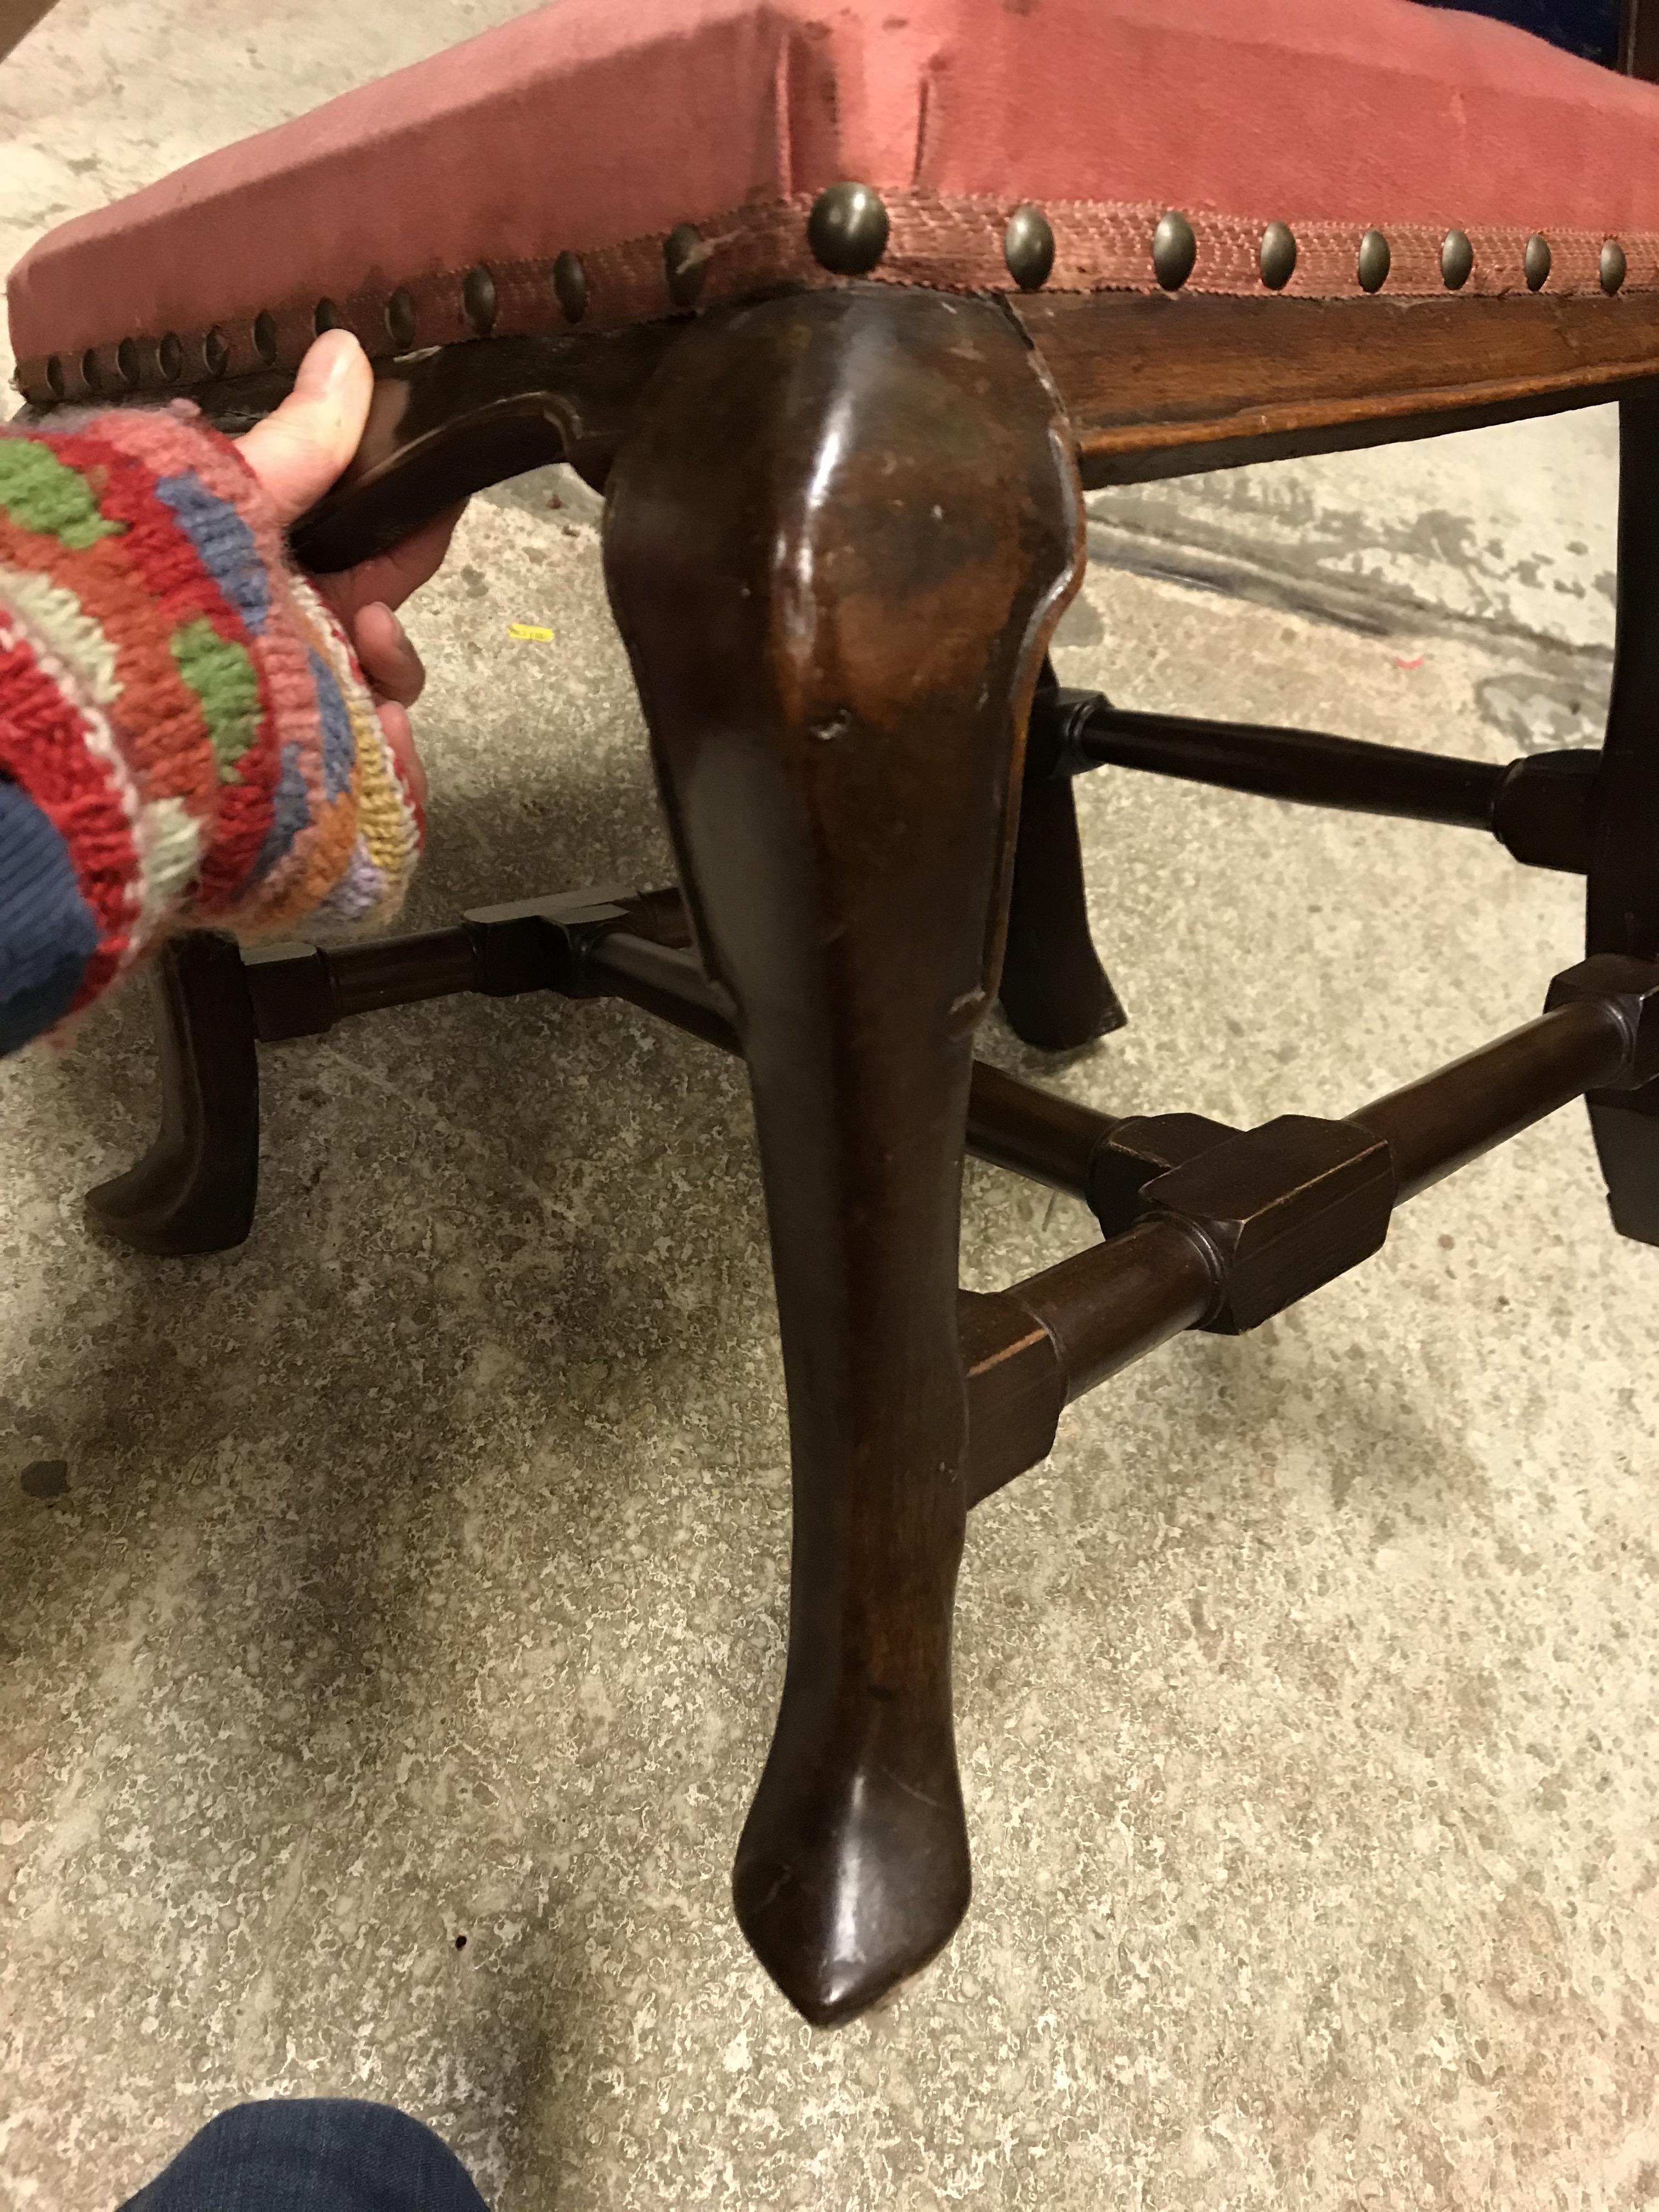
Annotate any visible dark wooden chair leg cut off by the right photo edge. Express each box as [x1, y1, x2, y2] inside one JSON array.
[[1588, 398, 1659, 1243]]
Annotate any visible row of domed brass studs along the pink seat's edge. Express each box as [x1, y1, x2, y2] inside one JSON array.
[[36, 184, 1626, 398]]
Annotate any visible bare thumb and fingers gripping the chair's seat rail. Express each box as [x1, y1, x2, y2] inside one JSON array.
[[239, 330, 460, 812]]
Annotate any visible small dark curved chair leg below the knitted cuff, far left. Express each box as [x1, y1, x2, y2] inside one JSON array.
[[86, 929, 259, 1256]]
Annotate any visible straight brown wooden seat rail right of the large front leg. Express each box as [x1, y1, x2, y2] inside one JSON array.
[[1011, 292, 1659, 487]]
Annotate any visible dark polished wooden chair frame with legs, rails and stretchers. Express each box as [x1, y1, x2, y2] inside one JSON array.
[[68, 281, 1659, 2022]]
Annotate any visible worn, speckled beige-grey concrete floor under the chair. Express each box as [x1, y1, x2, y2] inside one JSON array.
[[0, 0, 1659, 2212]]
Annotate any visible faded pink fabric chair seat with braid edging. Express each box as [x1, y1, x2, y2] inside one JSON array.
[[9, 0, 1659, 402]]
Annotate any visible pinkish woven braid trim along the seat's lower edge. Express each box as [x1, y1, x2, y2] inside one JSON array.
[[18, 190, 1659, 407]]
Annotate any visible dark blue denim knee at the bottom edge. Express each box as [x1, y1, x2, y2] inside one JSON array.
[[122, 2097, 489, 2212]]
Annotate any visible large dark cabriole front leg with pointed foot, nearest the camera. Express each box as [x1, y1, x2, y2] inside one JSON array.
[[606, 287, 1082, 2022]]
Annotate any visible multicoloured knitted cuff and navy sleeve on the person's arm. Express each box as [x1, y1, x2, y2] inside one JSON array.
[[0, 403, 425, 1053]]
